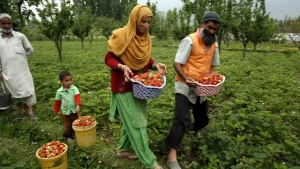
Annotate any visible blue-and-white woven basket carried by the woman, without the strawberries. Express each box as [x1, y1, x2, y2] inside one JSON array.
[[130, 76, 166, 99]]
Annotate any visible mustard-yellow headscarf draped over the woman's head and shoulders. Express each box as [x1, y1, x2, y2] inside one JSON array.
[[108, 5, 152, 70]]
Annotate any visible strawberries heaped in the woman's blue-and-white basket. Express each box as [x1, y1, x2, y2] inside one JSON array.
[[132, 72, 164, 87]]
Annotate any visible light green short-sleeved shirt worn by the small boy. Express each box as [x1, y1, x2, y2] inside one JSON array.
[[55, 85, 80, 115]]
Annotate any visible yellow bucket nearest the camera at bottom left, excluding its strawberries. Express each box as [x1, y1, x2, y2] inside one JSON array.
[[35, 143, 68, 169]]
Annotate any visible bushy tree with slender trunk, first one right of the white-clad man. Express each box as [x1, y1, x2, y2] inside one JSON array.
[[36, 0, 73, 61]]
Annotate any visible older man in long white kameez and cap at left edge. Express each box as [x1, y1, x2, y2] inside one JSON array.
[[0, 13, 37, 120]]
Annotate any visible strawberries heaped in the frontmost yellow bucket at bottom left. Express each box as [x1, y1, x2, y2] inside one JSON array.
[[38, 141, 66, 158]]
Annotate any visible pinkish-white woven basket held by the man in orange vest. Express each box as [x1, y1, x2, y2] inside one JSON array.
[[194, 76, 225, 96]]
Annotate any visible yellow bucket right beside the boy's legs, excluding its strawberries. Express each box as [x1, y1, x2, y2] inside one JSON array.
[[72, 118, 97, 147]]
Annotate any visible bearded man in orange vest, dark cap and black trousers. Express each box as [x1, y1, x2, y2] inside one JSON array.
[[166, 11, 221, 169]]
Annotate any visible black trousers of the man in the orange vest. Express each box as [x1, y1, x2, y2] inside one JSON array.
[[165, 93, 209, 149]]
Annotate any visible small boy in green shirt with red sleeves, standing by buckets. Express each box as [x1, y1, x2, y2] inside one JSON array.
[[53, 71, 82, 143]]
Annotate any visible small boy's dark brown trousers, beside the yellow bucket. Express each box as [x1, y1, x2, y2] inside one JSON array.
[[62, 113, 78, 138]]
